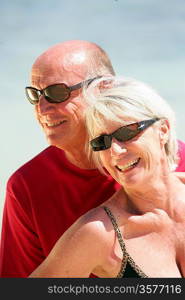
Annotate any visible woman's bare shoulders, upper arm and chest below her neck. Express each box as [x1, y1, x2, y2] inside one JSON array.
[[27, 183, 185, 278]]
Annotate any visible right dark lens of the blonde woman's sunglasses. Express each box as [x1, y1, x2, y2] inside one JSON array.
[[114, 124, 139, 142]]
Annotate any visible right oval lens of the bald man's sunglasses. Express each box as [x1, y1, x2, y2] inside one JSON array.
[[44, 84, 70, 103]]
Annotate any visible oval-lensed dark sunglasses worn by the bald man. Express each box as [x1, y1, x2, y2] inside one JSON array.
[[25, 76, 101, 105]]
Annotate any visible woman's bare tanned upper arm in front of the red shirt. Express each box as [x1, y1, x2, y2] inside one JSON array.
[[29, 212, 105, 278]]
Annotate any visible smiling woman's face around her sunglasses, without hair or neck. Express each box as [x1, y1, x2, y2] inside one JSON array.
[[98, 120, 168, 187]]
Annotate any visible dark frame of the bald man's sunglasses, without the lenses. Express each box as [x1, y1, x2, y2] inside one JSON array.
[[25, 76, 101, 105]]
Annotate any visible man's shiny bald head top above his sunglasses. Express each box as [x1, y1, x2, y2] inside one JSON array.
[[32, 40, 114, 88]]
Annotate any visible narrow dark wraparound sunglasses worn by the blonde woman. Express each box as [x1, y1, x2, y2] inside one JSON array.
[[90, 118, 159, 151]]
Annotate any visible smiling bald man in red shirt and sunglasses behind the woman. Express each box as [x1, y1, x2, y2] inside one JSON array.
[[0, 41, 185, 277]]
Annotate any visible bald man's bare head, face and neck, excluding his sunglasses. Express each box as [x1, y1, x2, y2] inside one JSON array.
[[31, 41, 113, 169]]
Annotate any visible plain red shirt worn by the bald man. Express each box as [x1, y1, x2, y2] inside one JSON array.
[[0, 142, 185, 277]]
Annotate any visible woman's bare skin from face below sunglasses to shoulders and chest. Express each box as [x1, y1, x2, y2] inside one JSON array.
[[30, 116, 185, 278]]
